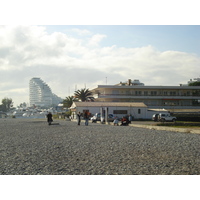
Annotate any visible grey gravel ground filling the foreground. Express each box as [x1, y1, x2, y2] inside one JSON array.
[[0, 119, 200, 175]]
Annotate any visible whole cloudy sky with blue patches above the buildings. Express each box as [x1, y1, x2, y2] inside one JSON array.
[[0, 25, 200, 105]]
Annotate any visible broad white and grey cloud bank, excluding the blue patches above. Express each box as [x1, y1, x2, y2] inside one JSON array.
[[0, 26, 200, 104]]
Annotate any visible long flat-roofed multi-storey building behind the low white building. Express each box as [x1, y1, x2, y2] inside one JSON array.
[[91, 79, 200, 108]]
